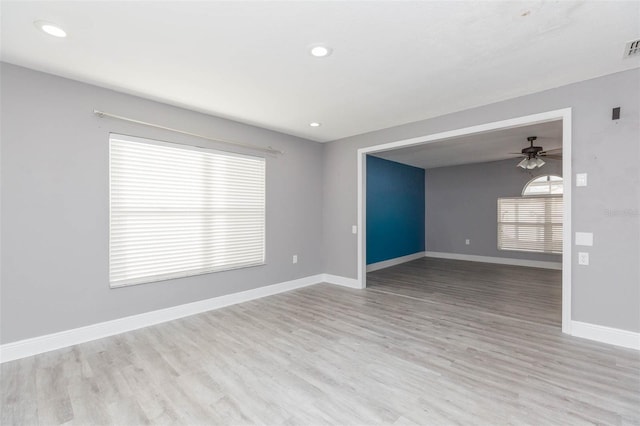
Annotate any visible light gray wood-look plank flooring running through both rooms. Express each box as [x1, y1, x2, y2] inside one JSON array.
[[0, 259, 640, 425]]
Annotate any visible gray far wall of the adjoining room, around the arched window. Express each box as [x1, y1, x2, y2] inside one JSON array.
[[425, 158, 562, 262]]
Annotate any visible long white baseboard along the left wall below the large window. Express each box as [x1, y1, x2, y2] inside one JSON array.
[[0, 274, 324, 363]]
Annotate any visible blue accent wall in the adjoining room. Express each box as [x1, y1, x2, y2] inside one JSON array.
[[367, 156, 425, 265]]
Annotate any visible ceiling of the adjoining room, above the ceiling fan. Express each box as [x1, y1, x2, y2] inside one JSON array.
[[373, 121, 562, 169]]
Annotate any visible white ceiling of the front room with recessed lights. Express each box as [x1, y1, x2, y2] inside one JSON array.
[[0, 1, 640, 141]]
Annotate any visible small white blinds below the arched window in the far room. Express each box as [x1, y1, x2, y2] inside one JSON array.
[[498, 196, 562, 253]]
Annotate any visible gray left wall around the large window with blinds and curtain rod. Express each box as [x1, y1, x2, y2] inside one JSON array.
[[0, 64, 323, 343]]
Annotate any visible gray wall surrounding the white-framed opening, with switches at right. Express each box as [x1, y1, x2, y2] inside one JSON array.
[[323, 69, 640, 332]]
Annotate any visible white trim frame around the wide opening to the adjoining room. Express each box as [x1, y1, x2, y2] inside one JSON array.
[[357, 108, 573, 334]]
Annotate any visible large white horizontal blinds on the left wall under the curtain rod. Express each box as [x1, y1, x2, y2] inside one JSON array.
[[109, 135, 265, 287]]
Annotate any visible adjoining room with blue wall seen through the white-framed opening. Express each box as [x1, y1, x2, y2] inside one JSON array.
[[366, 120, 570, 329]]
